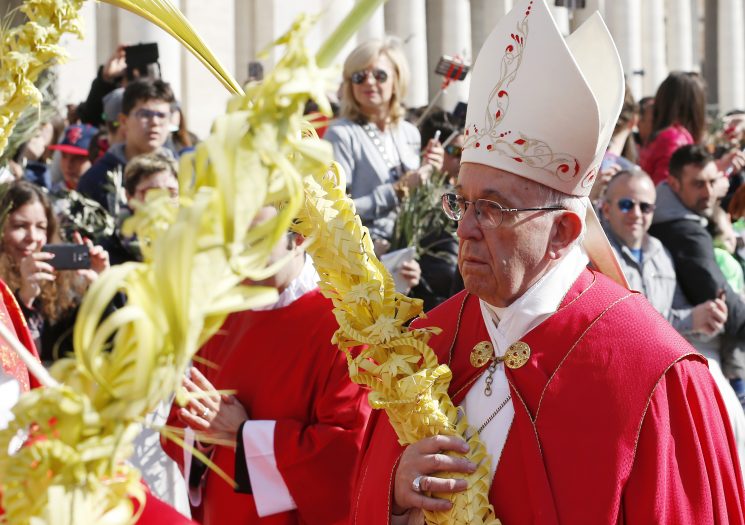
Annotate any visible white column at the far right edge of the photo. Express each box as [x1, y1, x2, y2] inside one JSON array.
[[717, 0, 745, 113]]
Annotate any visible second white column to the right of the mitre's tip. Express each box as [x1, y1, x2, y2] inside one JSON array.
[[641, 0, 668, 96]]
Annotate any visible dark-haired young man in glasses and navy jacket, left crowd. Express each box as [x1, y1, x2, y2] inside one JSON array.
[[78, 79, 175, 217]]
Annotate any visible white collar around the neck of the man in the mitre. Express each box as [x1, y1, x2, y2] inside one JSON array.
[[479, 245, 589, 355]]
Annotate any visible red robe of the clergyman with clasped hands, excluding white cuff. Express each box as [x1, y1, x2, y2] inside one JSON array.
[[167, 289, 370, 525]]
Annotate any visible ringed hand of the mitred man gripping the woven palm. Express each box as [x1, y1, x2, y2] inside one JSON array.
[[391, 436, 476, 515]]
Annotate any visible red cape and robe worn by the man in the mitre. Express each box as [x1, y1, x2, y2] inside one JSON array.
[[352, 270, 745, 525]]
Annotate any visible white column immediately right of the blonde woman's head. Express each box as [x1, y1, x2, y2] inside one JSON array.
[[385, 0, 432, 107]]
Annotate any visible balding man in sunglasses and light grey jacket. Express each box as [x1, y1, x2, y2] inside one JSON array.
[[602, 168, 727, 336]]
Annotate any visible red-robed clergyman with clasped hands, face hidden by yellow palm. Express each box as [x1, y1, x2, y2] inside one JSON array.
[[167, 208, 370, 525]]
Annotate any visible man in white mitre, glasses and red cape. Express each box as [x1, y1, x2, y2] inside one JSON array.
[[351, 0, 745, 525]]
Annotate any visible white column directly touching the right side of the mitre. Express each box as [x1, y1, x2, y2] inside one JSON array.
[[605, 0, 643, 99]]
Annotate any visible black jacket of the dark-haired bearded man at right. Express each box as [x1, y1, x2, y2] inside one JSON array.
[[649, 183, 745, 378]]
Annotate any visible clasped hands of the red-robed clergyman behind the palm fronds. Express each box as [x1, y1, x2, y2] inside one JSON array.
[[179, 368, 248, 446]]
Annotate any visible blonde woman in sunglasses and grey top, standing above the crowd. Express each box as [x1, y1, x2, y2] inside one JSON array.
[[324, 40, 443, 245]]
